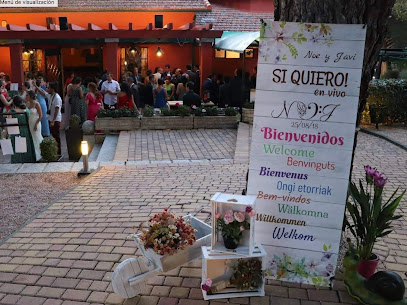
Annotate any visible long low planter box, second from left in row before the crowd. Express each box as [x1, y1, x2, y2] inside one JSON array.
[[141, 116, 194, 130]]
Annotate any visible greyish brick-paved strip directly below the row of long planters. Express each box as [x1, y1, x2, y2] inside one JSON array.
[[114, 129, 237, 161]]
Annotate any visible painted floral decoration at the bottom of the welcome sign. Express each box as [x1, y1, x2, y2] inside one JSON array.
[[265, 245, 336, 286]]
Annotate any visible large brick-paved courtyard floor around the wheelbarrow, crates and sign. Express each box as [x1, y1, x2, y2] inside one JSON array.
[[0, 128, 407, 305]]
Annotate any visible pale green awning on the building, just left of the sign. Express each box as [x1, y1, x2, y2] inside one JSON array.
[[215, 31, 260, 53]]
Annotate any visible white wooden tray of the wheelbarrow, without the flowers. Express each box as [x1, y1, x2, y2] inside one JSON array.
[[135, 215, 212, 272]]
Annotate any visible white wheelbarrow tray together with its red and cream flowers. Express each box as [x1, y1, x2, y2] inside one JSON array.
[[134, 209, 212, 272]]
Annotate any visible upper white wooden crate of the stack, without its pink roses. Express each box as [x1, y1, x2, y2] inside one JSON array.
[[211, 193, 256, 256]]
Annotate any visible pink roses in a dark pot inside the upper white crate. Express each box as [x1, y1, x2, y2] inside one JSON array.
[[215, 206, 256, 249]]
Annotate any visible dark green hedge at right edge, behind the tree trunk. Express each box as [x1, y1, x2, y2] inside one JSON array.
[[363, 79, 407, 123]]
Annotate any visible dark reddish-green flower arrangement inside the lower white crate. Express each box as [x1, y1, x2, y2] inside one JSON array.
[[230, 258, 263, 290]]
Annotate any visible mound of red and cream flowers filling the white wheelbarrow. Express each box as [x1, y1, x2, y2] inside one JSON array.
[[140, 209, 197, 255]]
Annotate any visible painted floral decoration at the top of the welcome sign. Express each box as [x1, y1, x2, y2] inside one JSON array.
[[259, 22, 333, 64]]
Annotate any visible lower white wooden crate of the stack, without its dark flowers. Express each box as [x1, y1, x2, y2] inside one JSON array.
[[202, 245, 266, 300]]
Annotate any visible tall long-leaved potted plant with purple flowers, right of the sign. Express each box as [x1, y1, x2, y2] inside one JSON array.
[[345, 166, 405, 278]]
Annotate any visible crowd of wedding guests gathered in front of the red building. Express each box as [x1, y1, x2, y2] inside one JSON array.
[[0, 64, 256, 162]]
